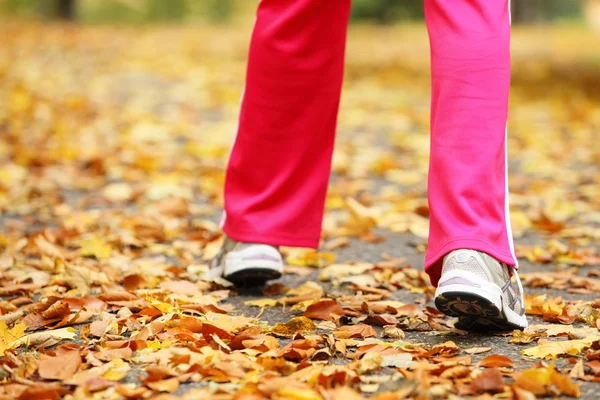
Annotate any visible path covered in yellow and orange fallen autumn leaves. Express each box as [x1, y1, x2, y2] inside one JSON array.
[[0, 25, 600, 400]]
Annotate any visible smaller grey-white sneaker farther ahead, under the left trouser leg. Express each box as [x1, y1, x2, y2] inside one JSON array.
[[206, 236, 283, 286]]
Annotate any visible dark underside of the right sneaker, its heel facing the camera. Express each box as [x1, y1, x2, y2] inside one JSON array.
[[435, 291, 523, 332]]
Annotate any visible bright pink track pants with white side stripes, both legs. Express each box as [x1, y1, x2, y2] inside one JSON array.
[[222, 0, 516, 285]]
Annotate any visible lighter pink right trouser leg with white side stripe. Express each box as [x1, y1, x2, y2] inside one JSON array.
[[425, 0, 516, 285]]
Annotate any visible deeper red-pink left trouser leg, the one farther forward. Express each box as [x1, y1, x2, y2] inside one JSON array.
[[222, 0, 350, 247]]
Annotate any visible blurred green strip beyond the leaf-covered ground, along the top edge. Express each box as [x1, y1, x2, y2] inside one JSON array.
[[0, 0, 598, 24]]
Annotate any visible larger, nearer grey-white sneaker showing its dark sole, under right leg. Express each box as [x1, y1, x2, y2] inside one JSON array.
[[435, 250, 528, 332]]
